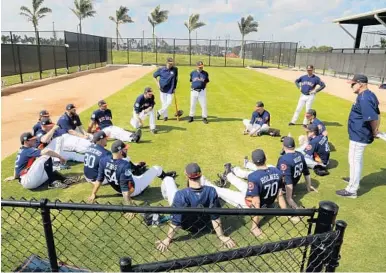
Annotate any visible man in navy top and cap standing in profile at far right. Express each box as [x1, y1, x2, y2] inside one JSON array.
[[336, 75, 380, 198]]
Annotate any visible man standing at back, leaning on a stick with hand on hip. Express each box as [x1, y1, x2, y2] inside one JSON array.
[[153, 58, 178, 121]]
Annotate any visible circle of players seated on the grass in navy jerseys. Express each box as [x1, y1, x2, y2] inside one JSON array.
[[9, 93, 330, 251]]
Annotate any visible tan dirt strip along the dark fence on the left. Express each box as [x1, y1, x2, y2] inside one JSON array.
[[1, 66, 155, 159]]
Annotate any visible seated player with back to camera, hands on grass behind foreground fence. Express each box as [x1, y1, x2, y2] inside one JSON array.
[[156, 163, 236, 252]]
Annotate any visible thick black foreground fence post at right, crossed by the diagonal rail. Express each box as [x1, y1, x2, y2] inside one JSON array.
[[306, 201, 339, 272]]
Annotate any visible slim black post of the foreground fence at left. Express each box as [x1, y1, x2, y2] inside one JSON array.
[[40, 199, 59, 272]]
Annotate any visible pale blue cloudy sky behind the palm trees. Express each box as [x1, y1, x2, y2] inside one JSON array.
[[1, 0, 386, 47]]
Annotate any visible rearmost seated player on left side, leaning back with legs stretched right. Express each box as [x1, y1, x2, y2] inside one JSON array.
[[87, 100, 142, 142]]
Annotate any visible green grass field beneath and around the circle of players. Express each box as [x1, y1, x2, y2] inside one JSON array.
[[1, 67, 386, 272]]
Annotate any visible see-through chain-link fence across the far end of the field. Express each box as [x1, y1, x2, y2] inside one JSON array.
[[109, 37, 297, 67]]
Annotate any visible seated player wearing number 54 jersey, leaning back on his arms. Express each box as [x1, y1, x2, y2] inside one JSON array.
[[88, 140, 176, 218]]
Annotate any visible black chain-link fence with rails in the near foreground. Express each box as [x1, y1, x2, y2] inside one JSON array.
[[1, 199, 346, 272]]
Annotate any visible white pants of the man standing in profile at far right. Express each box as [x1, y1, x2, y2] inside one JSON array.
[[346, 140, 368, 193]]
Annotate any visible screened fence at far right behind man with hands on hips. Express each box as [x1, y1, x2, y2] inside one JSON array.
[[296, 49, 386, 83]]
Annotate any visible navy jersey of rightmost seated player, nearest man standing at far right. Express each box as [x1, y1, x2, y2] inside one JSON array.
[[304, 135, 330, 165]]
